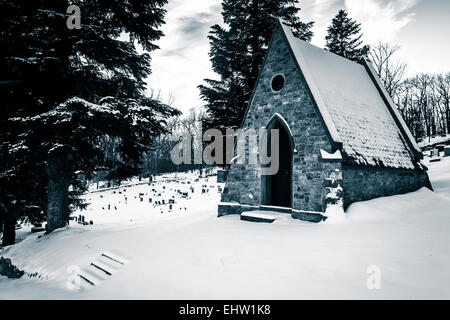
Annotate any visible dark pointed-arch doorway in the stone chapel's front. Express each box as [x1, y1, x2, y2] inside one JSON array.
[[262, 114, 294, 207]]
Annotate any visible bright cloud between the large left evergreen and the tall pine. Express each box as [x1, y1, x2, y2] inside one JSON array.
[[147, 0, 222, 111]]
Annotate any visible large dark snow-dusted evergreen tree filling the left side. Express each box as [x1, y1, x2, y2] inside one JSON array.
[[0, 0, 178, 240]]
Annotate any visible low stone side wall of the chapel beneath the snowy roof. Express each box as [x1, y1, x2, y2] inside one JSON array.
[[342, 165, 431, 208]]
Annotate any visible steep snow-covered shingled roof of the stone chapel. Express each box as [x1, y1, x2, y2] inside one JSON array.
[[280, 21, 419, 169]]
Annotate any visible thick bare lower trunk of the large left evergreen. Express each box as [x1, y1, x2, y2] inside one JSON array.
[[46, 154, 69, 233]]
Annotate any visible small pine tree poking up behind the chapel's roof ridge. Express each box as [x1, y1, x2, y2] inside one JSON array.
[[325, 10, 363, 61]]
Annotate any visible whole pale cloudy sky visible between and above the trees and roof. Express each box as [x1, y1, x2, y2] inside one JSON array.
[[148, 0, 450, 112]]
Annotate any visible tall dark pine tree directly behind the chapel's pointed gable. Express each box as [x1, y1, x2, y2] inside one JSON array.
[[199, 0, 313, 129]]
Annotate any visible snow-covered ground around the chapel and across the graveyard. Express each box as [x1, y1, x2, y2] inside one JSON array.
[[0, 158, 450, 299]]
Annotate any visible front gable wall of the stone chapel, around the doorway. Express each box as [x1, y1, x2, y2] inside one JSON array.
[[222, 24, 335, 211]]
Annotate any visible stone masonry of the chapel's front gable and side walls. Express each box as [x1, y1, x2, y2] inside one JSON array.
[[219, 21, 431, 222]]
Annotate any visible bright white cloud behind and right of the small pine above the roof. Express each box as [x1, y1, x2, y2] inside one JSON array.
[[345, 0, 418, 43]]
